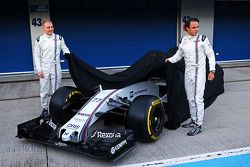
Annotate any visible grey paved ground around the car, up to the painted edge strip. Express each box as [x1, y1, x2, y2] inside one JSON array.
[[0, 67, 250, 167]]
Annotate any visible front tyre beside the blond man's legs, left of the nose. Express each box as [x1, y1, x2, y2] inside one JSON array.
[[49, 86, 84, 125]]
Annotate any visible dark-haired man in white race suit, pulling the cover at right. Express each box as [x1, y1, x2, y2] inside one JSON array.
[[165, 18, 215, 136]]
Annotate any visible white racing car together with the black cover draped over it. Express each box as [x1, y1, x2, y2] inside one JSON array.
[[17, 49, 224, 160]]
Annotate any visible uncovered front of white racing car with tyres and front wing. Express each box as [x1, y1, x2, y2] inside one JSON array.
[[17, 81, 165, 160]]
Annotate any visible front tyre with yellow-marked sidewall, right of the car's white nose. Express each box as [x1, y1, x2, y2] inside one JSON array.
[[126, 95, 165, 142]]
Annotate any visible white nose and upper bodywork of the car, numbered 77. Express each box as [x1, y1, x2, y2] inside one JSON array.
[[59, 81, 159, 143]]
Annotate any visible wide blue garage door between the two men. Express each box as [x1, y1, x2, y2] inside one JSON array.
[[50, 0, 177, 68]]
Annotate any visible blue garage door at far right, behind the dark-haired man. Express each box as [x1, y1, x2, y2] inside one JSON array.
[[214, 2, 250, 61]]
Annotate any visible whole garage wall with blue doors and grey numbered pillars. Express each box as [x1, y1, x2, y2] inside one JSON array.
[[0, 0, 250, 75]]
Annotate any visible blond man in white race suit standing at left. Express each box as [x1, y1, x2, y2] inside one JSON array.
[[34, 20, 70, 119]]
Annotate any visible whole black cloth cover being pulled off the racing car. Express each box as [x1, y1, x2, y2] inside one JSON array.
[[65, 48, 224, 129]]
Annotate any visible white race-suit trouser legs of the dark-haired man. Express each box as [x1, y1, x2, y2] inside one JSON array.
[[185, 67, 206, 125]]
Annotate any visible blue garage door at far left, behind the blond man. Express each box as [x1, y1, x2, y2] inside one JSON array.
[[0, 0, 33, 73]]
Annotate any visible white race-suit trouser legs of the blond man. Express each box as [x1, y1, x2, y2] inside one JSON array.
[[40, 63, 62, 110]]
